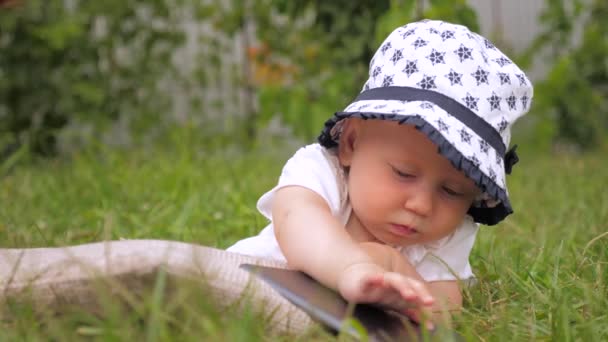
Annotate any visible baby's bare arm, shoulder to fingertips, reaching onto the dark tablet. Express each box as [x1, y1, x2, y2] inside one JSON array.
[[272, 186, 434, 311]]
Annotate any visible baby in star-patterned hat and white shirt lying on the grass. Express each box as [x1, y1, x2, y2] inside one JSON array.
[[228, 20, 532, 321]]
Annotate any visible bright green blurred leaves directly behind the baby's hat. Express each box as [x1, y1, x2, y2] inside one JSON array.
[[249, 0, 479, 140]]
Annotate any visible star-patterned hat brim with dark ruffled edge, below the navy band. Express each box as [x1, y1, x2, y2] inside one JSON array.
[[318, 100, 513, 225]]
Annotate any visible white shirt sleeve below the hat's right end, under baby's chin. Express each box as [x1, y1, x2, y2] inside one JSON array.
[[415, 216, 479, 281]]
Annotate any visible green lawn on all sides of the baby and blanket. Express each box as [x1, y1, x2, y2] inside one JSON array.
[[0, 132, 608, 341]]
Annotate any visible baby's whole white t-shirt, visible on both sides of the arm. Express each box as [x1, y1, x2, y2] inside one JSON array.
[[228, 144, 478, 281]]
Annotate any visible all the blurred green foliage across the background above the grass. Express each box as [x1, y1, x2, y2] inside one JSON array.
[[0, 0, 608, 155]]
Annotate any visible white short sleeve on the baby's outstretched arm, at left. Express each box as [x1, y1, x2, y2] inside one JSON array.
[[257, 144, 341, 220]]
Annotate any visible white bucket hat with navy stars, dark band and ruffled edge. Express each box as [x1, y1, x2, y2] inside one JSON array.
[[318, 20, 533, 225]]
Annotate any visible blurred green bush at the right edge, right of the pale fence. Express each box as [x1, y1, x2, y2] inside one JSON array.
[[524, 0, 608, 150]]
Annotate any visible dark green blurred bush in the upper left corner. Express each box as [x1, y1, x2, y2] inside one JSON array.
[[0, 0, 184, 155]]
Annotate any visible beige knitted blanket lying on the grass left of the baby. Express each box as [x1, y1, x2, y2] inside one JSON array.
[[0, 240, 311, 334]]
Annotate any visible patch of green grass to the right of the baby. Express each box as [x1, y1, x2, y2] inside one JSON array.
[[462, 152, 608, 341]]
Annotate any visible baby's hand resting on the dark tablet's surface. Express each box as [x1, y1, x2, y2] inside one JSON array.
[[338, 263, 435, 322]]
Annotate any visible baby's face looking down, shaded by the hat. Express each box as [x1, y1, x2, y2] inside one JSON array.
[[339, 119, 479, 246]]
